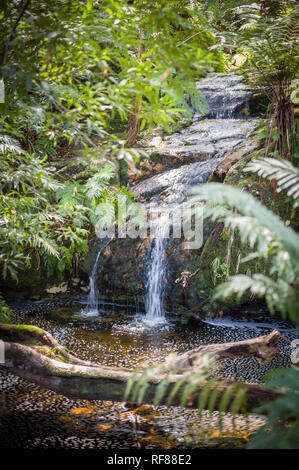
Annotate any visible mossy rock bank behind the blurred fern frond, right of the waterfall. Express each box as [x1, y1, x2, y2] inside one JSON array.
[[197, 149, 299, 306]]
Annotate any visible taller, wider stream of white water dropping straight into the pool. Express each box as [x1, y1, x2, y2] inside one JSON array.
[[145, 218, 169, 325]]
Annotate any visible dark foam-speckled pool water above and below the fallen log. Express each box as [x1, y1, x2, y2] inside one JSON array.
[[0, 302, 297, 449]]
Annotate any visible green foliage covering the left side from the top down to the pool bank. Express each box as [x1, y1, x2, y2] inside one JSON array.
[[0, 0, 222, 278]]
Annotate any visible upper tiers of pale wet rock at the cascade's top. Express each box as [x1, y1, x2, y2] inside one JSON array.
[[134, 74, 258, 184]]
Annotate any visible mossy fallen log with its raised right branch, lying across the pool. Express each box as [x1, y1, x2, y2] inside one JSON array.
[[0, 325, 280, 412]]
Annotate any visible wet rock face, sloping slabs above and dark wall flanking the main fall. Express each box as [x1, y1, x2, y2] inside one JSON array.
[[88, 74, 258, 310]]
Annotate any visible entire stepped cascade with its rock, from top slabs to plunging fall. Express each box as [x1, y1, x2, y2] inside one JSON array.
[[90, 73, 260, 308]]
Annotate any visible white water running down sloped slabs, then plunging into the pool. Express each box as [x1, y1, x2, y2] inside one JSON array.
[[134, 74, 258, 325]]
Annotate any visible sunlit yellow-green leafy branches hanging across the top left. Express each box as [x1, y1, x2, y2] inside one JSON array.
[[0, 0, 217, 158]]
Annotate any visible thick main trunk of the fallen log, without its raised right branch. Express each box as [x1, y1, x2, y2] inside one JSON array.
[[1, 342, 279, 412]]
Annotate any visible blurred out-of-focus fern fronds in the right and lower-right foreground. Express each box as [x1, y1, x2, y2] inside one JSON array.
[[127, 159, 299, 448]]
